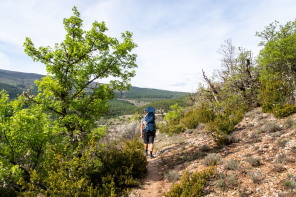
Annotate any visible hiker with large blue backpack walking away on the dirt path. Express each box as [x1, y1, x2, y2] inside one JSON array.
[[141, 107, 156, 158]]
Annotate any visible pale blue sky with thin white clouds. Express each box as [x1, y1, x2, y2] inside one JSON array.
[[0, 0, 296, 92]]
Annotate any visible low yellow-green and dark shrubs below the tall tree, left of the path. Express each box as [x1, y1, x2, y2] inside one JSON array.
[[19, 139, 147, 197]]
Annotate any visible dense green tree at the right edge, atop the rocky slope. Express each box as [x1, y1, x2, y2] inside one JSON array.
[[257, 21, 296, 117]]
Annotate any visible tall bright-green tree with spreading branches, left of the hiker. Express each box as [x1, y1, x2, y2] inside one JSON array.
[[24, 7, 137, 145]]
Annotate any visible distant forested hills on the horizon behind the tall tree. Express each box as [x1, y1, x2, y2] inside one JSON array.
[[0, 69, 188, 116]]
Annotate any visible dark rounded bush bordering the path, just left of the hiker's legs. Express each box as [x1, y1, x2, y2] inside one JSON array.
[[88, 138, 148, 196]]
